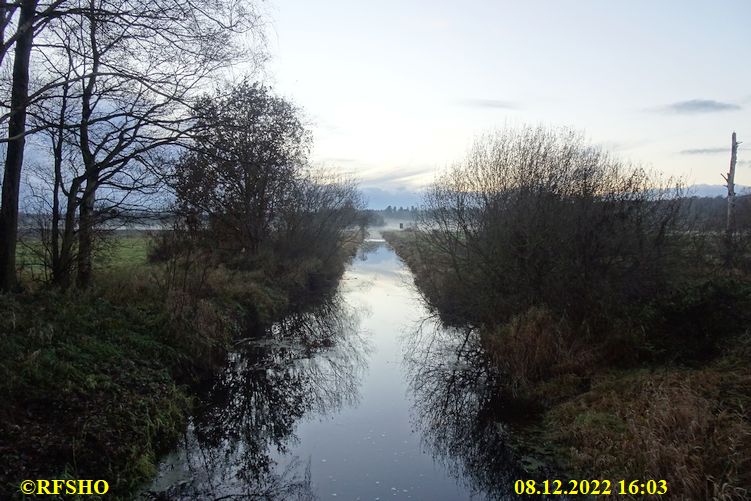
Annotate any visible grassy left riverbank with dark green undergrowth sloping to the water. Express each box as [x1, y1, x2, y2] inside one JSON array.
[[0, 232, 358, 499]]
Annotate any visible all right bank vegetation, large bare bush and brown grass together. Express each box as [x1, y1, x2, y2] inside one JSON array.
[[384, 124, 751, 499]]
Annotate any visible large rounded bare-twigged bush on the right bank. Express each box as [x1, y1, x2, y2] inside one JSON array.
[[420, 128, 680, 327]]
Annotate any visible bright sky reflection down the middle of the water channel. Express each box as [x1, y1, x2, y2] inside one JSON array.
[[280, 240, 482, 500]]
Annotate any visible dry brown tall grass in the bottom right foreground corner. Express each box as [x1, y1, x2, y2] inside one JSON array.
[[547, 358, 751, 500]]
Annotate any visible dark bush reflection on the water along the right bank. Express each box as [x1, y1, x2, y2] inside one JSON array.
[[405, 319, 560, 499]]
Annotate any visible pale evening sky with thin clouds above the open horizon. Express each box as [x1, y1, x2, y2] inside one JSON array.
[[250, 0, 751, 207]]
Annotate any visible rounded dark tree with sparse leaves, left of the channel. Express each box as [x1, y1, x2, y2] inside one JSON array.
[[174, 80, 310, 254]]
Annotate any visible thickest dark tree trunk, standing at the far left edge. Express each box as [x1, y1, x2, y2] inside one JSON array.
[[0, 0, 38, 291]]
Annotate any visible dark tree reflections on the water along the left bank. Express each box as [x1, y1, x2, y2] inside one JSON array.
[[144, 296, 367, 499]]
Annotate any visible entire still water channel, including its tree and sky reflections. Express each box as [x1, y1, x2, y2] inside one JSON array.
[[144, 240, 539, 501]]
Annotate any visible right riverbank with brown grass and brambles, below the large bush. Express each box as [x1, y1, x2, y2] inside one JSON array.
[[384, 231, 751, 499]]
